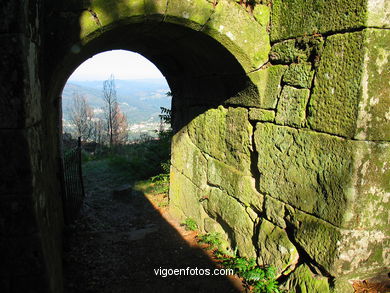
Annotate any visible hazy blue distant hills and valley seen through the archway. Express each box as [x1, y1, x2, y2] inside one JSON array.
[[62, 79, 171, 124]]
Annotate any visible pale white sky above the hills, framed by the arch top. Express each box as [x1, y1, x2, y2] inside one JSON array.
[[69, 50, 164, 81]]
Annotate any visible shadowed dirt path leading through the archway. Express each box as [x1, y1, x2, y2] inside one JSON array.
[[64, 161, 242, 293]]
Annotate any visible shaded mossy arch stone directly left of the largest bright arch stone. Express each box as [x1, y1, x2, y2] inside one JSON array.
[[164, 0, 214, 30]]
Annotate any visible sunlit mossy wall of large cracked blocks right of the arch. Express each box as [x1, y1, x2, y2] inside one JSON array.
[[170, 1, 390, 292]]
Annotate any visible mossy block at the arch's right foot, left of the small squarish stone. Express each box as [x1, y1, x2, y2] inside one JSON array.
[[249, 65, 287, 109]]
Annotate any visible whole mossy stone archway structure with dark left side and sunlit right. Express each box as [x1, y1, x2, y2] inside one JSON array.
[[0, 0, 390, 293]]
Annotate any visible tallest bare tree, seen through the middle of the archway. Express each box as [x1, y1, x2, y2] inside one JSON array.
[[103, 75, 128, 148]]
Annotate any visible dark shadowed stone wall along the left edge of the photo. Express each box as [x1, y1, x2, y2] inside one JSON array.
[[0, 1, 62, 293]]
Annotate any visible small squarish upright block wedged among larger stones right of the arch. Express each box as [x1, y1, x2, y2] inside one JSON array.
[[275, 86, 310, 127]]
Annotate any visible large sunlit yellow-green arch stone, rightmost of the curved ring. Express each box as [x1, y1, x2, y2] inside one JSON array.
[[202, 0, 270, 72]]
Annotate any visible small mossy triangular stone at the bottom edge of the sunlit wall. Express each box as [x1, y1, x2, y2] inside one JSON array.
[[283, 264, 333, 293]]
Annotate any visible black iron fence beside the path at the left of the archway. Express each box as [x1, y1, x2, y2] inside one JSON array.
[[63, 137, 85, 224]]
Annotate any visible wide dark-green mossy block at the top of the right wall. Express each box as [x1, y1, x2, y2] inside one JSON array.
[[271, 0, 367, 41]]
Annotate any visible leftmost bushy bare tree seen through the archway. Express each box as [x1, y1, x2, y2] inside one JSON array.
[[69, 92, 94, 141]]
